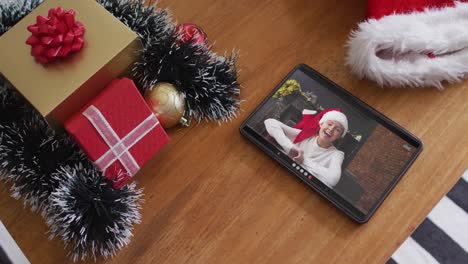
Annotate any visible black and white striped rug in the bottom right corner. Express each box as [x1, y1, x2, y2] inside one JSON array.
[[387, 170, 468, 264]]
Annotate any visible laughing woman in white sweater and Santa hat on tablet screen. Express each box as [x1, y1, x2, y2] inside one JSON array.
[[265, 108, 348, 187]]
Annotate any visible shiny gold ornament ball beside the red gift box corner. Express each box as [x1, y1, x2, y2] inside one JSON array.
[[145, 82, 185, 128]]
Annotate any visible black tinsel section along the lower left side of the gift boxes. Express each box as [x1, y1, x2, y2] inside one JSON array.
[[0, 77, 142, 260]]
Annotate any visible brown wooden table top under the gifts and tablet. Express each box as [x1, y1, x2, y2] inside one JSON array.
[[0, 0, 468, 263]]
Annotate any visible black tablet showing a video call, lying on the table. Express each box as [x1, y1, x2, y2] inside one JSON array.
[[240, 64, 422, 223]]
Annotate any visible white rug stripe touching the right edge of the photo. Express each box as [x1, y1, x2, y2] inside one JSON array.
[[427, 196, 468, 252]]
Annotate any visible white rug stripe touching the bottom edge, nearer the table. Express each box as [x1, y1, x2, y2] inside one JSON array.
[[392, 237, 439, 264]]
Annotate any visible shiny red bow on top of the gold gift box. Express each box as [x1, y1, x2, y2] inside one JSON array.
[[26, 7, 85, 64]]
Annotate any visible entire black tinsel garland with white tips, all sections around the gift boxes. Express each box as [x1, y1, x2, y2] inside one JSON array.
[[0, 0, 239, 260]]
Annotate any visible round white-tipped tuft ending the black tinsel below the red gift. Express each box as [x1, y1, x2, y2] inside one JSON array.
[[46, 164, 142, 261]]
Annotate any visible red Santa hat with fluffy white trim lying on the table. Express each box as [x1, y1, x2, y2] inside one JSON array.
[[347, 0, 468, 89]]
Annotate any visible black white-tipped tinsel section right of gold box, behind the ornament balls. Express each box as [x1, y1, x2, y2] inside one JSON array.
[[98, 0, 240, 122]]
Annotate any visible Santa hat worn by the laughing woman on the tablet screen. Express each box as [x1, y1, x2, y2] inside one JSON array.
[[294, 108, 348, 143]]
